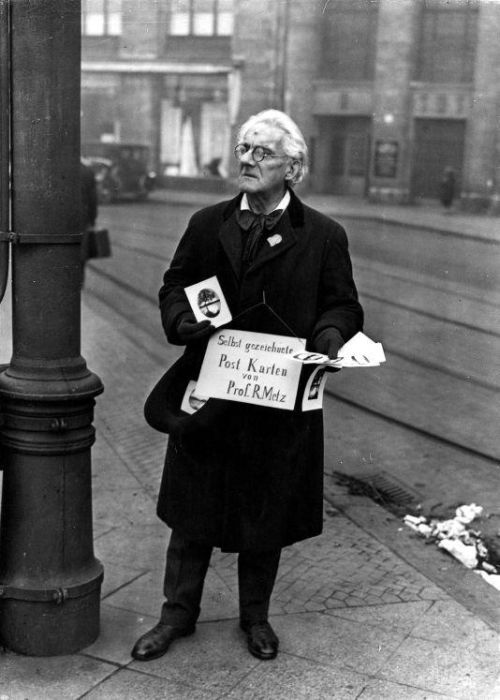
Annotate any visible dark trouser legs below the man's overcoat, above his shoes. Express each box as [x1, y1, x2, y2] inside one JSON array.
[[161, 531, 281, 627]]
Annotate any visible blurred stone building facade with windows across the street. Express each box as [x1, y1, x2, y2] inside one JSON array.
[[82, 0, 500, 211]]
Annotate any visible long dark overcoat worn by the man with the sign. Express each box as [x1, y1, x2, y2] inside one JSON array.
[[152, 192, 363, 551]]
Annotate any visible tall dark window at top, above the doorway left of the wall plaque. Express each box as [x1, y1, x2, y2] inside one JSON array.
[[320, 0, 378, 80]]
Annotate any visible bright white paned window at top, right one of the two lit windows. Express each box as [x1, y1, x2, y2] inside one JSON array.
[[170, 0, 233, 36]]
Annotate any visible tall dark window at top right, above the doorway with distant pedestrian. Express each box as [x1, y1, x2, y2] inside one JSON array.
[[415, 0, 479, 83]]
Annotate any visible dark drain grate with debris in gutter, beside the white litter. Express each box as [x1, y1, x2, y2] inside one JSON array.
[[332, 471, 422, 514]]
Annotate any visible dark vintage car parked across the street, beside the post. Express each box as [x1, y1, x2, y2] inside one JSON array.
[[82, 142, 156, 203]]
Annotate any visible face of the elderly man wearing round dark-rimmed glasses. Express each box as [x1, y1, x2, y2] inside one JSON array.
[[238, 124, 293, 199]]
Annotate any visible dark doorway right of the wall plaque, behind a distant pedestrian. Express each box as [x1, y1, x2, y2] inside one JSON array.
[[412, 119, 465, 199]]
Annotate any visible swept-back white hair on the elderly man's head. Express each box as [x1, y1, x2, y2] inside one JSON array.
[[237, 109, 309, 186]]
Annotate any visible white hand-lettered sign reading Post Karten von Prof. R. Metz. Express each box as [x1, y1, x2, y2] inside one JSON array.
[[196, 329, 306, 411]]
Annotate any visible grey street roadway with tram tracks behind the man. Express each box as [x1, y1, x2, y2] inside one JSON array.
[[88, 186, 500, 516]]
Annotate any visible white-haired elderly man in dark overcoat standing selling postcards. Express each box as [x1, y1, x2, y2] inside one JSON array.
[[132, 110, 363, 661]]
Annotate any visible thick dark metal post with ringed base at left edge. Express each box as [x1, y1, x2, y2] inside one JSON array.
[[0, 0, 103, 656]]
